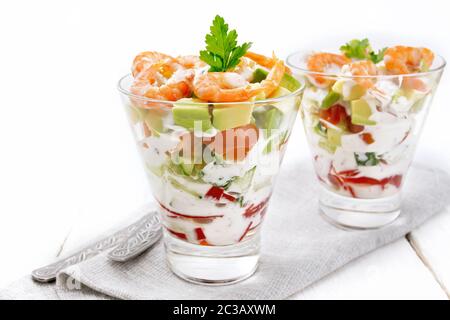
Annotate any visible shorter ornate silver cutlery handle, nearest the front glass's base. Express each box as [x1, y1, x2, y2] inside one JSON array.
[[108, 214, 162, 262]]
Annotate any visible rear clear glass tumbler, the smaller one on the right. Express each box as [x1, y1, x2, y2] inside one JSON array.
[[287, 52, 445, 229]]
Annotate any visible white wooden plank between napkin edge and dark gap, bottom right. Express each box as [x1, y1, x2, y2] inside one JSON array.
[[291, 238, 447, 299]]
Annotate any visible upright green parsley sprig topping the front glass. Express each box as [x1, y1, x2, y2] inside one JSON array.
[[200, 15, 252, 72]]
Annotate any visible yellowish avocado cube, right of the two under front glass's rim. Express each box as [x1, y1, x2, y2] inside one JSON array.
[[212, 103, 253, 131]]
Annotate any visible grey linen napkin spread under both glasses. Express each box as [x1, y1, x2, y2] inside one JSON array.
[[0, 164, 450, 299]]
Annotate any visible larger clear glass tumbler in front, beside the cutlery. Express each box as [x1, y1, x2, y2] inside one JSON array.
[[119, 75, 303, 284]]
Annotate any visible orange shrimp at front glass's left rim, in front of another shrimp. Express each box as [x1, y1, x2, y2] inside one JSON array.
[[130, 67, 194, 101]]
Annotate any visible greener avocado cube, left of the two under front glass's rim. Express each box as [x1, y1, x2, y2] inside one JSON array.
[[172, 99, 212, 131]]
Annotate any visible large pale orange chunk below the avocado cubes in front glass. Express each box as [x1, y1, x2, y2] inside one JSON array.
[[208, 124, 259, 161]]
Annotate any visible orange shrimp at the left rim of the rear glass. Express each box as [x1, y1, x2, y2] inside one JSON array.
[[307, 52, 351, 86]]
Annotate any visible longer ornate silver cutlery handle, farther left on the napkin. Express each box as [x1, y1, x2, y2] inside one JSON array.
[[31, 212, 155, 282]]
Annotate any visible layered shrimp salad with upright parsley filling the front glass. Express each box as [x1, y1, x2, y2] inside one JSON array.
[[123, 16, 301, 246]]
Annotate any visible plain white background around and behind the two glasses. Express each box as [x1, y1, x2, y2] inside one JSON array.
[[0, 0, 450, 298]]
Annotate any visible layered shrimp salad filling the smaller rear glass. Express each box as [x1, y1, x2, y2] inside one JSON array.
[[299, 39, 439, 199]]
